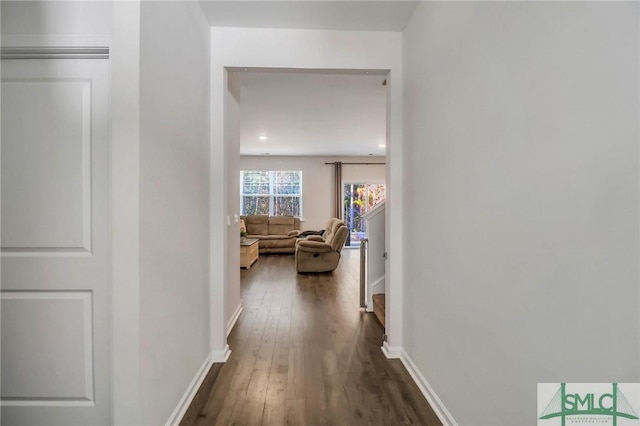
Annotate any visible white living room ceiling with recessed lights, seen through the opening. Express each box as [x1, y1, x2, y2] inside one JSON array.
[[239, 71, 387, 156]]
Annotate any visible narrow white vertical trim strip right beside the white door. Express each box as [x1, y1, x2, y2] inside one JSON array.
[[110, 1, 140, 425]]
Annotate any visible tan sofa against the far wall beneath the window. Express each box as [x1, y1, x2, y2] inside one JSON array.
[[241, 215, 300, 254]]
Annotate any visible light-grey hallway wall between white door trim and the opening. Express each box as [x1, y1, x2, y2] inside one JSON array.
[[140, 2, 210, 424]]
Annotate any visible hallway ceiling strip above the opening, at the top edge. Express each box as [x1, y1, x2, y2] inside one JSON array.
[[200, 0, 418, 31]]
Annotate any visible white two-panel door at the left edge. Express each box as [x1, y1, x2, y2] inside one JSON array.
[[0, 55, 111, 425]]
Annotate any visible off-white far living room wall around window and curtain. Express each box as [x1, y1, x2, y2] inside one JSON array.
[[238, 156, 385, 231]]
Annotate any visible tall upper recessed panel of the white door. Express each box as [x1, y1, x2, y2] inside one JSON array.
[[1, 78, 91, 253]]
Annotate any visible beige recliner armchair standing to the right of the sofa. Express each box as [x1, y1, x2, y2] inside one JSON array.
[[296, 218, 349, 272]]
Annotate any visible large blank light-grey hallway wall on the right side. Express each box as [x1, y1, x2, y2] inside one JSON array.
[[403, 2, 640, 425]]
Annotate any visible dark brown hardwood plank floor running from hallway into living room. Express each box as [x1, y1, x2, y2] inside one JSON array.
[[181, 249, 441, 426]]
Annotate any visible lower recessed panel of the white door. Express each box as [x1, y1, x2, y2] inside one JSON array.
[[0, 291, 94, 406]]
